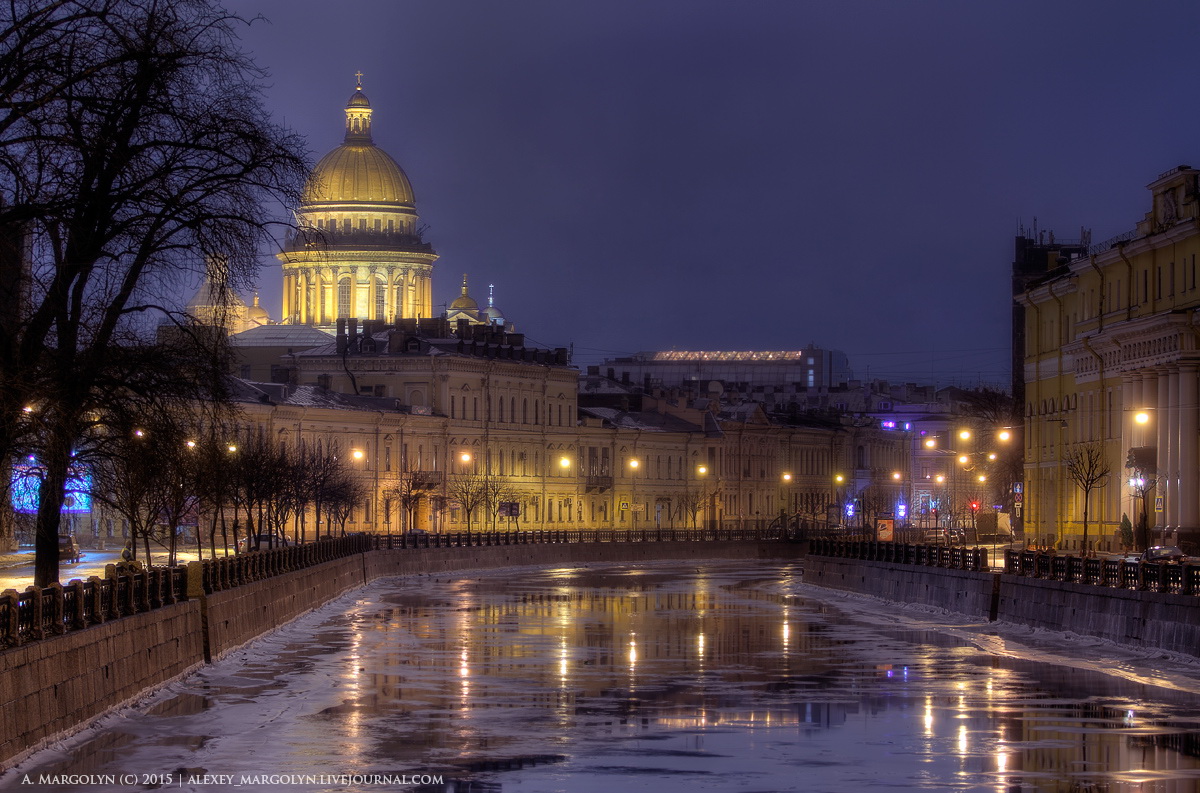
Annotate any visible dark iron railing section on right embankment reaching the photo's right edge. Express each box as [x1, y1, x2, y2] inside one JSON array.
[[1004, 551, 1200, 595]]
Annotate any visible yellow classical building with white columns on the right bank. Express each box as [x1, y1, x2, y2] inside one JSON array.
[[1018, 166, 1200, 547]]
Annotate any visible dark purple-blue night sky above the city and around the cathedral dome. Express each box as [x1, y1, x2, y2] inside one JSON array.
[[229, 0, 1200, 385]]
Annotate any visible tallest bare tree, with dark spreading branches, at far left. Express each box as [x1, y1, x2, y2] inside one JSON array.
[[0, 0, 306, 585]]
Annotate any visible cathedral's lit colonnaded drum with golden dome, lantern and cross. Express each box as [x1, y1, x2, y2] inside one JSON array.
[[278, 80, 438, 330]]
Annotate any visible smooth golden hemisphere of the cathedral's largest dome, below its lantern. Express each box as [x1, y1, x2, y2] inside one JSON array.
[[304, 143, 415, 204]]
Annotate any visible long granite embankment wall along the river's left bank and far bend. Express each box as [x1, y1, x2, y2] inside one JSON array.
[[0, 541, 803, 770]]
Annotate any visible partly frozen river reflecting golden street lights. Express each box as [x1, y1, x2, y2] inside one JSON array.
[[7, 561, 1200, 793]]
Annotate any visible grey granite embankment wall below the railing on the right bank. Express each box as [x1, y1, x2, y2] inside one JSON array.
[[804, 555, 1200, 655]]
